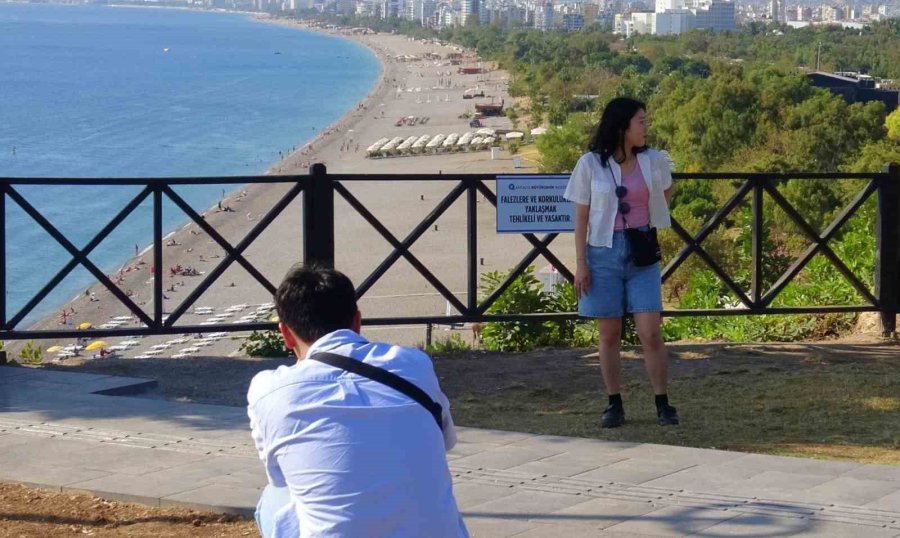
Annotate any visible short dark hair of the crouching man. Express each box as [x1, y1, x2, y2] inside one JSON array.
[[275, 265, 357, 344]]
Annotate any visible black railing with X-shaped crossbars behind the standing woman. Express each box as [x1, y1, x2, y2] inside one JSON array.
[[0, 164, 900, 340]]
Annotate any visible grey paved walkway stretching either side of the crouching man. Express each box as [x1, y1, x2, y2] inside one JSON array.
[[0, 367, 900, 538]]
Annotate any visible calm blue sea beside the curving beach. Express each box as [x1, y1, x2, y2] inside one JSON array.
[[0, 2, 382, 329]]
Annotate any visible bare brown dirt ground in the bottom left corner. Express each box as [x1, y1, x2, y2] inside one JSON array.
[[0, 483, 259, 538]]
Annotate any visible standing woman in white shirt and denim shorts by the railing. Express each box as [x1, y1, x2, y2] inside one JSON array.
[[565, 97, 679, 428]]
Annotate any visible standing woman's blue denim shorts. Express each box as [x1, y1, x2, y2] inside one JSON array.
[[578, 231, 662, 318]]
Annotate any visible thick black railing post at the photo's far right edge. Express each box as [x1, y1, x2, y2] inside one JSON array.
[[875, 163, 900, 337]]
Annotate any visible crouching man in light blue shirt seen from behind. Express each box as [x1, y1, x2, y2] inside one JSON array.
[[247, 266, 468, 538]]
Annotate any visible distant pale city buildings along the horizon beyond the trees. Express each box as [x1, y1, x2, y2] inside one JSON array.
[[109, 0, 900, 33]]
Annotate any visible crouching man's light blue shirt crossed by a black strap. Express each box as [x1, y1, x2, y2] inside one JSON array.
[[247, 330, 468, 538]]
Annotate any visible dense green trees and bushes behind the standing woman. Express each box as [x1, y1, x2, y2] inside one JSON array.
[[298, 13, 900, 349]]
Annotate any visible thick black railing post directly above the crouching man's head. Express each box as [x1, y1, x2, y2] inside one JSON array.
[[303, 163, 334, 267]]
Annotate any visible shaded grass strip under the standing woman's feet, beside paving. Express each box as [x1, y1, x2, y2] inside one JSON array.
[[437, 343, 900, 465]]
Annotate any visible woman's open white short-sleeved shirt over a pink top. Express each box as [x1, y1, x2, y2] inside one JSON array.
[[564, 149, 672, 247]]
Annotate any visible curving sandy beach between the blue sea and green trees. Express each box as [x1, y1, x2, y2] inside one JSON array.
[[21, 21, 574, 361]]
